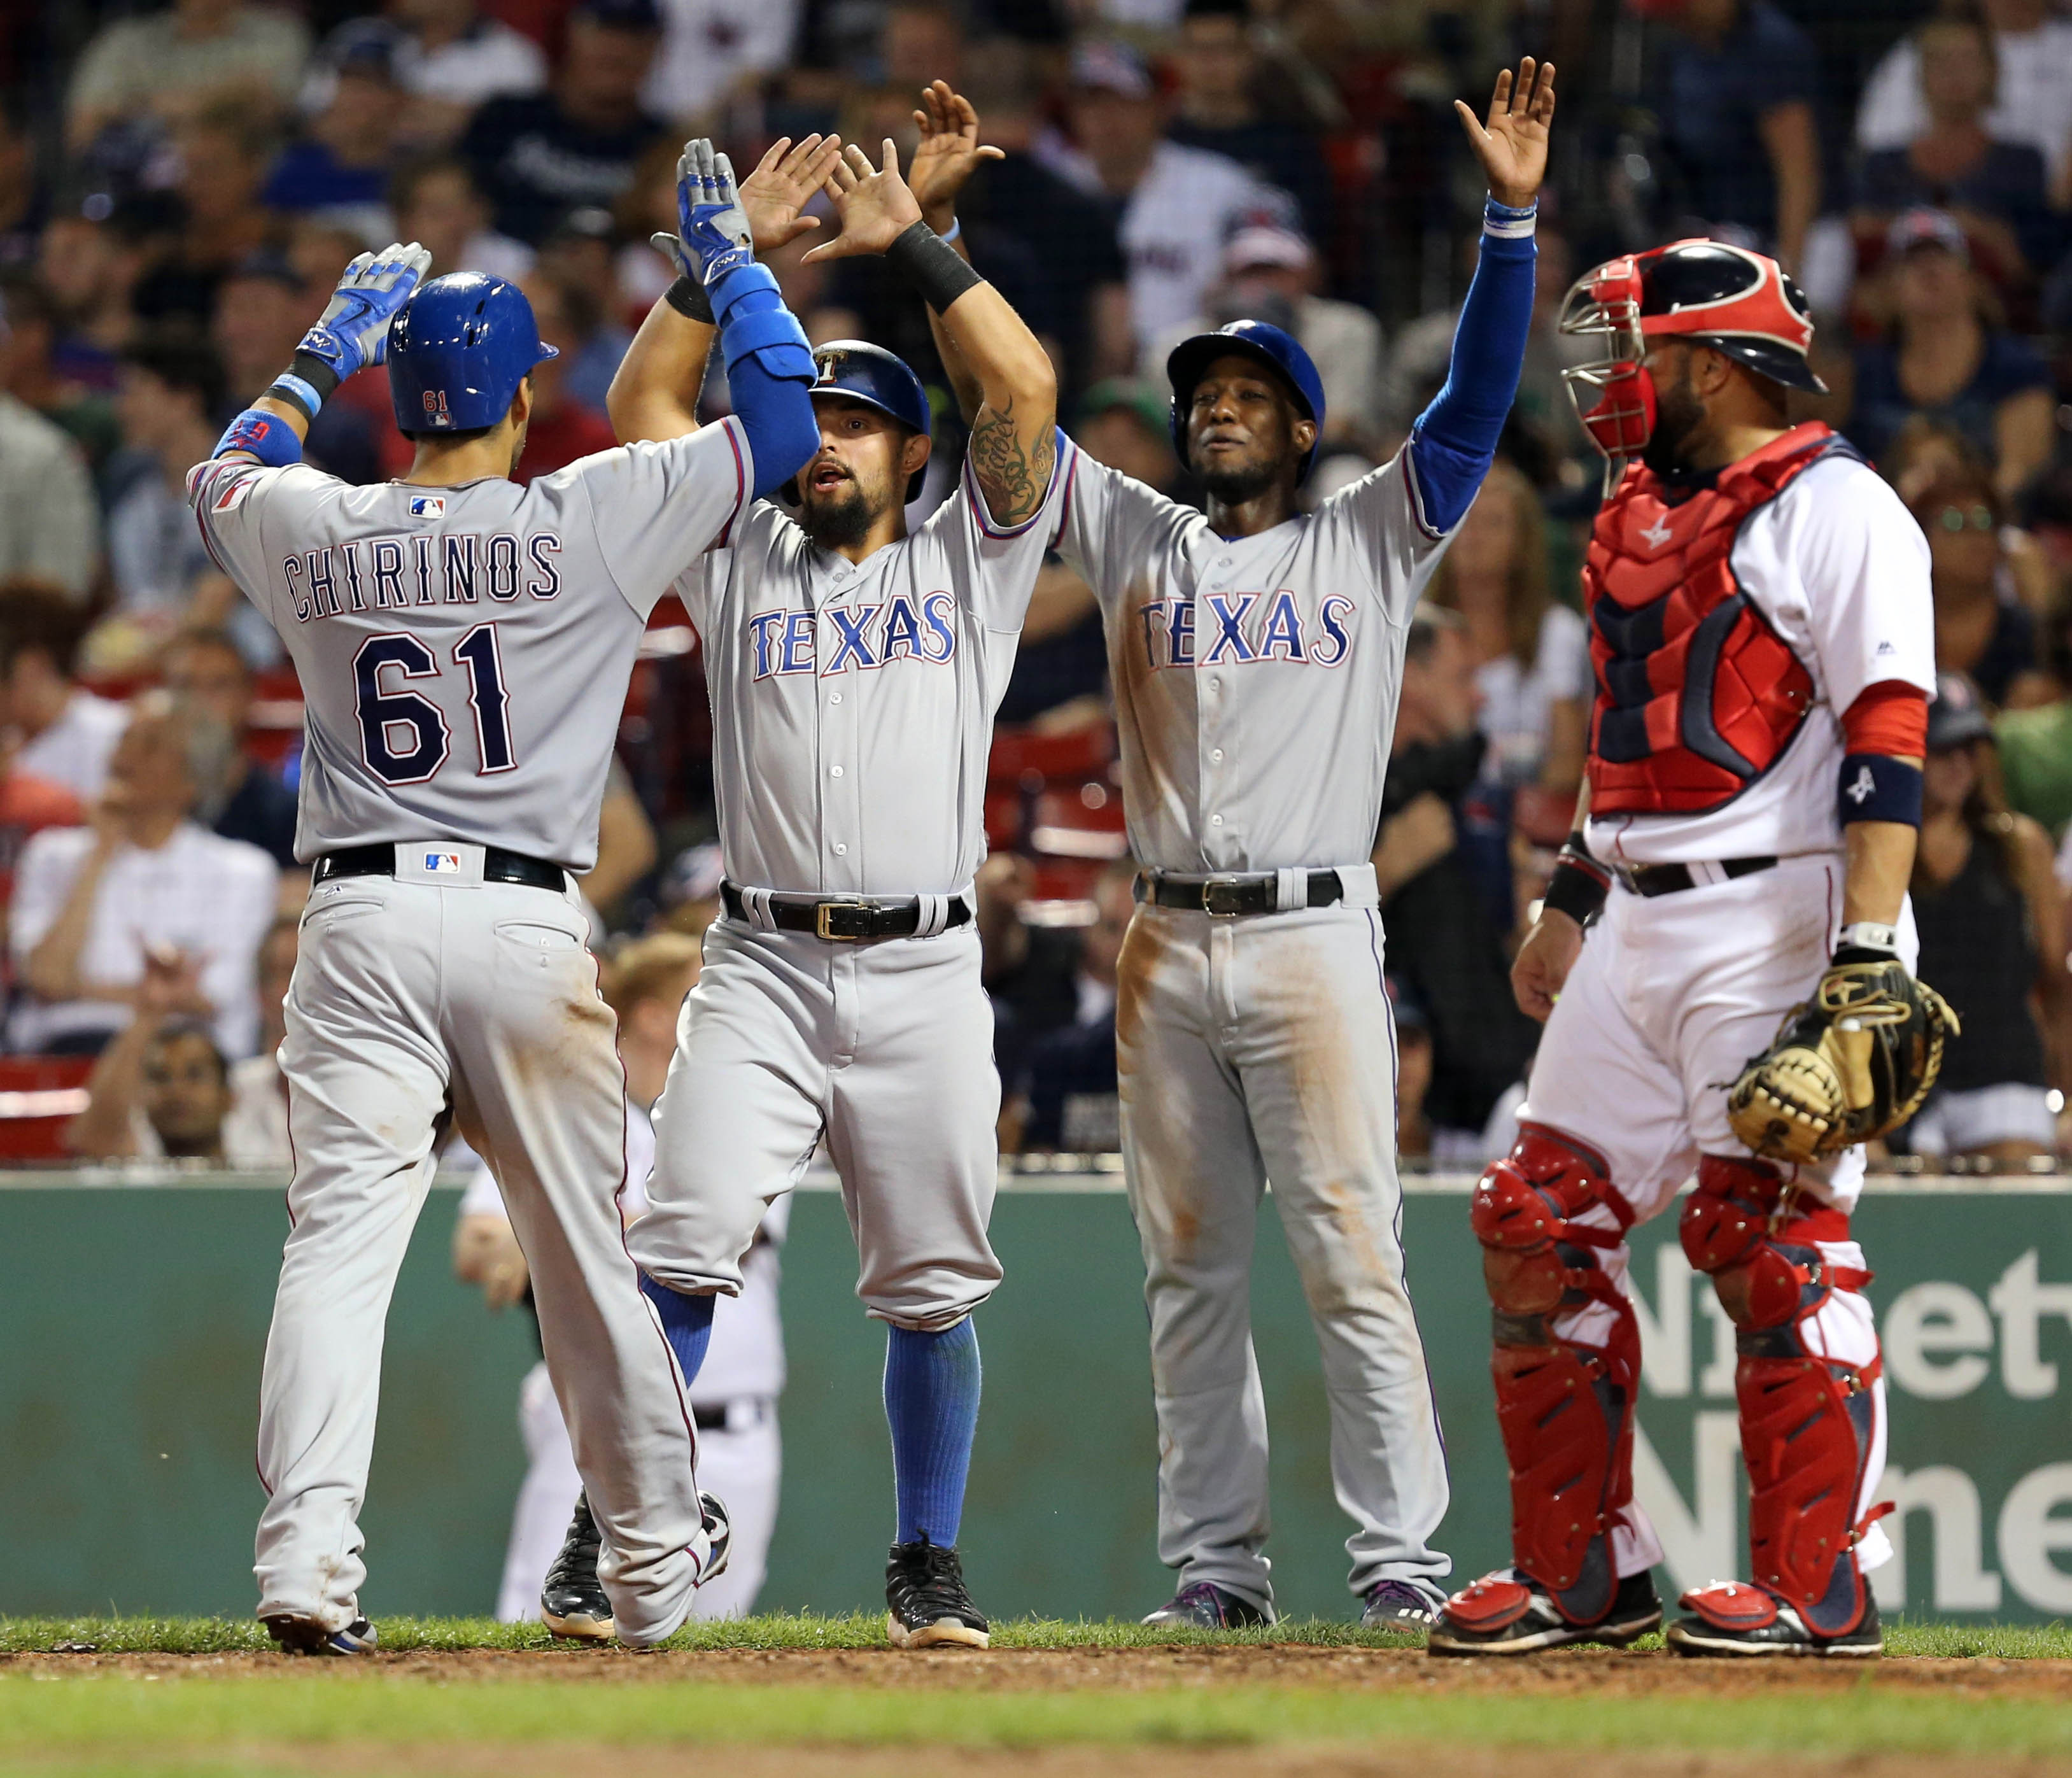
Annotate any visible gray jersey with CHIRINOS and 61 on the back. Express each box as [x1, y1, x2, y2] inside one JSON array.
[[188, 421, 752, 872]]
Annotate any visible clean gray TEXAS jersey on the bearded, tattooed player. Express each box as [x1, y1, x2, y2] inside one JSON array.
[[677, 441, 1078, 895]]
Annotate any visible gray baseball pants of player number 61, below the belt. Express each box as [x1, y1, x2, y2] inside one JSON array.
[[255, 857, 707, 1643]]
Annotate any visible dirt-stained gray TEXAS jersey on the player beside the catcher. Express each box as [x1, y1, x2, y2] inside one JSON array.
[[1057, 452, 1446, 872]]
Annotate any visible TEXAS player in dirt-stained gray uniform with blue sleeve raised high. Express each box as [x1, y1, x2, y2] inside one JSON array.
[[924, 58, 1554, 1635]]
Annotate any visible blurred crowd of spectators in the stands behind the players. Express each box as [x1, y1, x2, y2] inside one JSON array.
[[0, 0, 2072, 1164]]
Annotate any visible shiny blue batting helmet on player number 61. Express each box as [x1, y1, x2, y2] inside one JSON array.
[[388, 271, 560, 433]]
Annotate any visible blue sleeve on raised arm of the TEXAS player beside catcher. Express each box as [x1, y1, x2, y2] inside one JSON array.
[[1409, 212, 1537, 533]]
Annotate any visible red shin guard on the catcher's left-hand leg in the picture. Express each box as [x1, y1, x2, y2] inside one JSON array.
[[1471, 1123, 1641, 1623]]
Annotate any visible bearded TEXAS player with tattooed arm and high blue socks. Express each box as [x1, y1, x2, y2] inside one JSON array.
[[542, 141, 1071, 1647]]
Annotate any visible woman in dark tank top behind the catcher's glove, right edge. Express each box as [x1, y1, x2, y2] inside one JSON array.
[[1904, 672, 2072, 1162]]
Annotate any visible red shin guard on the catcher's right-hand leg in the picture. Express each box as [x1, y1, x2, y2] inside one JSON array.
[[1681, 1154, 1882, 1637]]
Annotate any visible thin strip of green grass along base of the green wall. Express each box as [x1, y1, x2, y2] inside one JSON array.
[[0, 1612, 2072, 1660]]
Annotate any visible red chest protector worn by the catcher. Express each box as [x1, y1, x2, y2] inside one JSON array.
[[1583, 421, 1848, 814]]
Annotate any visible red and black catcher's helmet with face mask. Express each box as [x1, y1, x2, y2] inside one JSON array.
[[1560, 241, 1828, 472]]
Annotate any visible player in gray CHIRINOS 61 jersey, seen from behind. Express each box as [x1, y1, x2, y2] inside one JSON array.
[[188, 141, 816, 1654]]
